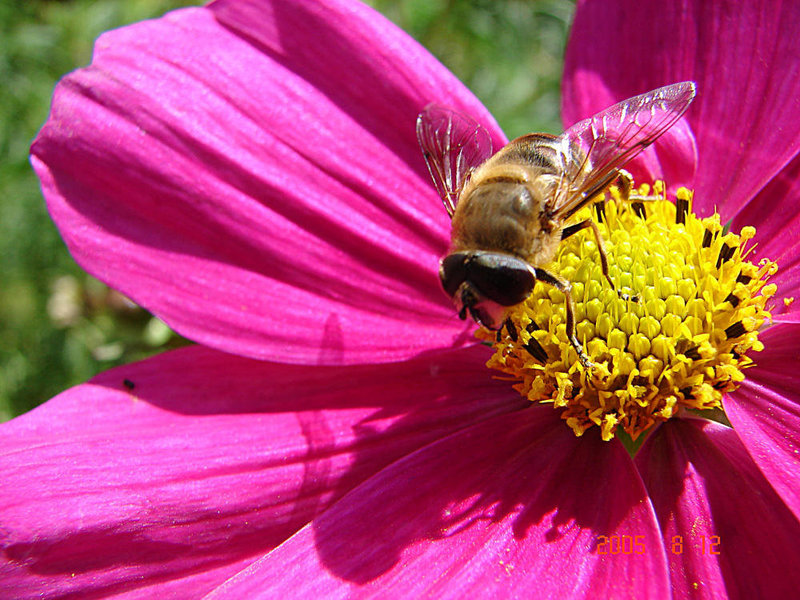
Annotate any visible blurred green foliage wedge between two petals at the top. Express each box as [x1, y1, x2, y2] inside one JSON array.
[[367, 0, 574, 138]]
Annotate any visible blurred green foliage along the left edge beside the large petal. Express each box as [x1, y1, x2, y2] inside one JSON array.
[[0, 0, 197, 421]]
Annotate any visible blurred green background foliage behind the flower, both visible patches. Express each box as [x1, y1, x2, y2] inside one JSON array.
[[0, 0, 573, 421]]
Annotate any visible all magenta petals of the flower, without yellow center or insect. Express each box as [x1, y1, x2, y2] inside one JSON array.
[[0, 0, 800, 598]]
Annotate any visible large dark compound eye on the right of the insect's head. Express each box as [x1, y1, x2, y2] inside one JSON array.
[[467, 253, 536, 306]]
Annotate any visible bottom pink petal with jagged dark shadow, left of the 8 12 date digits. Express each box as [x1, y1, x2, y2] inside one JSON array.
[[212, 406, 669, 598]]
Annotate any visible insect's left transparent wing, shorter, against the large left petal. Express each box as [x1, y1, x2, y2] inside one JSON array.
[[417, 104, 492, 217]]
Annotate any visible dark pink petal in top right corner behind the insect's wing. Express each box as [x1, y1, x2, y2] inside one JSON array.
[[563, 0, 800, 220]]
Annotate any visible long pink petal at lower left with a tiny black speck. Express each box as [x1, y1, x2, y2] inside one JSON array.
[[0, 347, 526, 598]]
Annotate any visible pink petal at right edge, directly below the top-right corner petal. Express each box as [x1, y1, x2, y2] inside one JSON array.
[[732, 155, 800, 326]]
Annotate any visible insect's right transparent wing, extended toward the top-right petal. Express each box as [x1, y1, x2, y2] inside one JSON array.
[[555, 81, 696, 218]]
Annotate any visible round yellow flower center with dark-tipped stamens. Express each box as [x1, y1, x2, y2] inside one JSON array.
[[478, 182, 777, 441]]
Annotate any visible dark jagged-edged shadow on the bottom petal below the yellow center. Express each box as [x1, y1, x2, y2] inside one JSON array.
[[313, 406, 647, 585]]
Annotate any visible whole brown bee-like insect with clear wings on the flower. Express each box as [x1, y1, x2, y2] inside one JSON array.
[[417, 81, 695, 367]]
